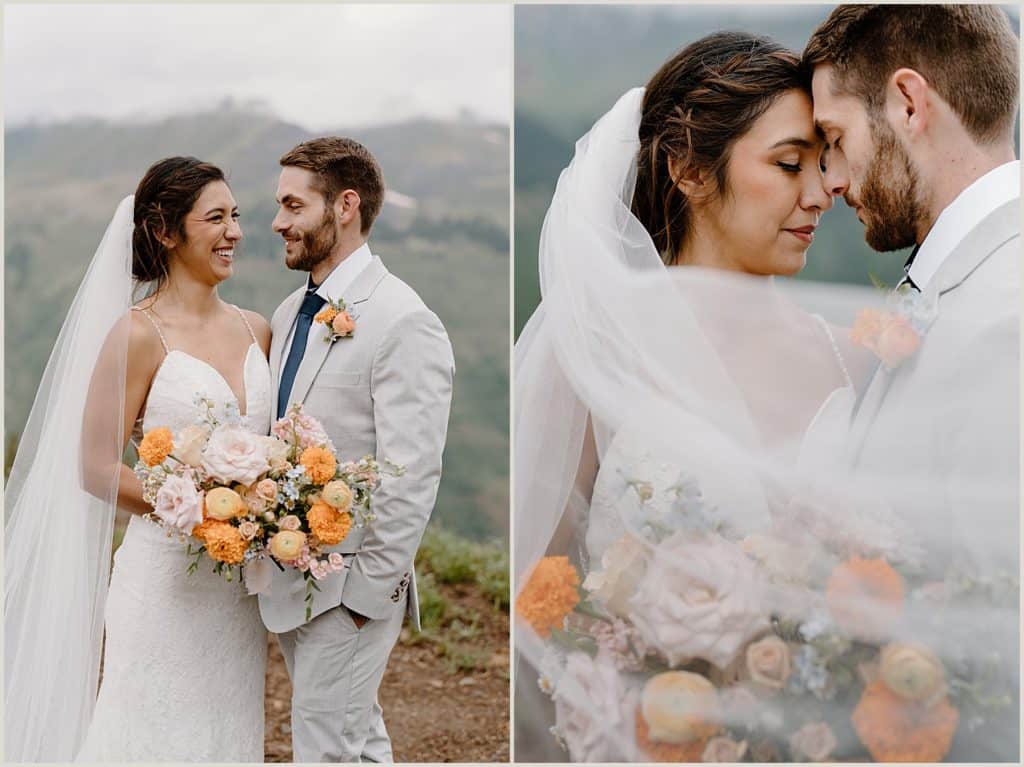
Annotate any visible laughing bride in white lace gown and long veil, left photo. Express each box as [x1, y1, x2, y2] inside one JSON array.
[[4, 158, 271, 762]]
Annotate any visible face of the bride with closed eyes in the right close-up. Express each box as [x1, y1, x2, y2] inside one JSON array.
[[690, 90, 831, 274]]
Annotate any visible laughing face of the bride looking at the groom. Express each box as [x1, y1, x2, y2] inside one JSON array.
[[170, 181, 242, 285]]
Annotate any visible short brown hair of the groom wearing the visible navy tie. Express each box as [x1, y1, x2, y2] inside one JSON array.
[[281, 136, 384, 235]]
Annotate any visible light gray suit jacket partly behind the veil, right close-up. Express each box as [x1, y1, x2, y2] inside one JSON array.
[[851, 198, 1021, 572]]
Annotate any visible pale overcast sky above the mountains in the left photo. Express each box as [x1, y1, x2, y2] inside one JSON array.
[[4, 4, 512, 130]]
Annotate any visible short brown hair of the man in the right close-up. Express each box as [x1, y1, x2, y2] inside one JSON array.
[[803, 4, 1019, 143]]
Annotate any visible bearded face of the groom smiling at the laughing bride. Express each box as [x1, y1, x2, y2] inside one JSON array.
[[273, 166, 339, 271]]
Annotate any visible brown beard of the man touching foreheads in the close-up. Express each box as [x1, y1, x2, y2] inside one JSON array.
[[854, 121, 924, 253]]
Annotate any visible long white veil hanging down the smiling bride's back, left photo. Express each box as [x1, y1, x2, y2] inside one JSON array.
[[4, 197, 138, 762]]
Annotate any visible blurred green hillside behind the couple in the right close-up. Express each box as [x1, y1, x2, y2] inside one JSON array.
[[514, 5, 1019, 335]]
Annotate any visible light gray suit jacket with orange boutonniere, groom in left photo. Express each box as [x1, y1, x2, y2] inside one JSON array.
[[259, 256, 455, 634]]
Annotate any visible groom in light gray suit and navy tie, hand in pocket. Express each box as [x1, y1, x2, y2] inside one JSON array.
[[259, 136, 455, 762]]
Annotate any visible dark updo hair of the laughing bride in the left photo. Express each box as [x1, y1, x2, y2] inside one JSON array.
[[131, 157, 225, 285]]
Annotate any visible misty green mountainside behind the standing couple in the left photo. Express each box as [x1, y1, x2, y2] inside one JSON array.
[[4, 103, 509, 540]]
